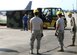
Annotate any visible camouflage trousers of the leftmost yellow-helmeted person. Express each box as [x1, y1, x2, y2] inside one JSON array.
[[30, 30, 42, 50]]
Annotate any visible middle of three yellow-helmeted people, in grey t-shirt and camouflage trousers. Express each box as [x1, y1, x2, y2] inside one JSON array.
[[56, 11, 64, 52]]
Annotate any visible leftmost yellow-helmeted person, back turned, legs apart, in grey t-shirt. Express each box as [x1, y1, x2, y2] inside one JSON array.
[[30, 10, 43, 54]]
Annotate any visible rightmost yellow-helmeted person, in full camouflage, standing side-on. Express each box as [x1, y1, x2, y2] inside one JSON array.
[[67, 12, 76, 46]]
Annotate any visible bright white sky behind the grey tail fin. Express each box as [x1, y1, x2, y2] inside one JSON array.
[[0, 0, 77, 10]]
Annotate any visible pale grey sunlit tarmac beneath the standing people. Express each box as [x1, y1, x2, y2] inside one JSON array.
[[0, 27, 77, 55]]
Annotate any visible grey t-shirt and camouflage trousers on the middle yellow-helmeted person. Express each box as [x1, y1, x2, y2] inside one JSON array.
[[56, 18, 64, 50]]
